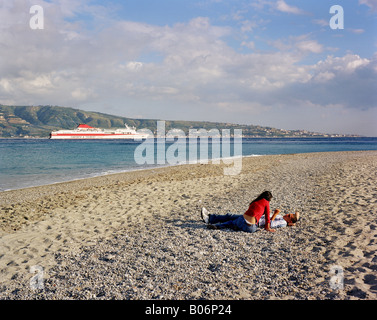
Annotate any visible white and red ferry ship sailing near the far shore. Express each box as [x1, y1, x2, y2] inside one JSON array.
[[50, 124, 148, 139]]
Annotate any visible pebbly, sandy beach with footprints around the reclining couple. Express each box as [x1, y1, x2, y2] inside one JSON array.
[[0, 151, 377, 300]]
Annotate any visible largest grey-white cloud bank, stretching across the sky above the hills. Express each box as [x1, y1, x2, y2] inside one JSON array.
[[0, 0, 377, 132]]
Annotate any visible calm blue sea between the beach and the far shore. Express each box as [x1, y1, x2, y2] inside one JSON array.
[[0, 138, 377, 191]]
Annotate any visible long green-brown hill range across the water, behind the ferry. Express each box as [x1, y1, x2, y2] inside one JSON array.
[[0, 105, 352, 138]]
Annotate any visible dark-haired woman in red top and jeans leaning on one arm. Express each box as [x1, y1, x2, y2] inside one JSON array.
[[201, 191, 275, 233]]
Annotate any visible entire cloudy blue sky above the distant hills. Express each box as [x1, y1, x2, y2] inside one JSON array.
[[0, 0, 377, 136]]
